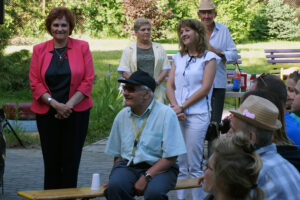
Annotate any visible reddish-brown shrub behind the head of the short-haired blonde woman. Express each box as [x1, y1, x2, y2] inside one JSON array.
[[122, 0, 173, 39]]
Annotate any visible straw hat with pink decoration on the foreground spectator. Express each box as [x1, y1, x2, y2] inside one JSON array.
[[230, 95, 281, 130]]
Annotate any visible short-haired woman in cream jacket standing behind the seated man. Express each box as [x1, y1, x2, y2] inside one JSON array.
[[117, 18, 171, 103]]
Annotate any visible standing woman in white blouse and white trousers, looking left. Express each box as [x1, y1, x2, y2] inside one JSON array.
[[167, 19, 220, 199]]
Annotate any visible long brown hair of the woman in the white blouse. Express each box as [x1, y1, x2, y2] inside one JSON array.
[[177, 19, 208, 57]]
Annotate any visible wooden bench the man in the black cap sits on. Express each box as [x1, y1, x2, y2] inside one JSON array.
[[18, 178, 201, 200]]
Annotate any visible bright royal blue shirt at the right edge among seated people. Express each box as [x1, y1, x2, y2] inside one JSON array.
[[284, 112, 300, 150]]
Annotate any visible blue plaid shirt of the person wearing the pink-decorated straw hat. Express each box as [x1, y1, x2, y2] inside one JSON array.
[[256, 144, 300, 200]]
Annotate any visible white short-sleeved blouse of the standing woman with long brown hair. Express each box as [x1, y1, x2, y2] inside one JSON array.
[[173, 51, 221, 114]]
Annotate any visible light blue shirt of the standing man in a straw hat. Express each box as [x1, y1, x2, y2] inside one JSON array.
[[209, 22, 238, 88]]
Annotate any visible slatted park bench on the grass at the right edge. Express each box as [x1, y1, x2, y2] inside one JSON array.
[[265, 49, 300, 79]]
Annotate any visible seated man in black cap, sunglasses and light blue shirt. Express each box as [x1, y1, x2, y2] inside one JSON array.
[[105, 71, 186, 200]]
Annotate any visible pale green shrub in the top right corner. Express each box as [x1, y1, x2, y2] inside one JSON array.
[[266, 0, 300, 40]]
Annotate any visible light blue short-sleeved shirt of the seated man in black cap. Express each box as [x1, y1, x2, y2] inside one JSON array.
[[105, 101, 186, 165]]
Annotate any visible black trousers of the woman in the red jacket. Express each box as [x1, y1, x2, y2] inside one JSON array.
[[36, 108, 90, 189]]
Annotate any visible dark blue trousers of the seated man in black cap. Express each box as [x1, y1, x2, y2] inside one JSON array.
[[104, 160, 178, 200]]
